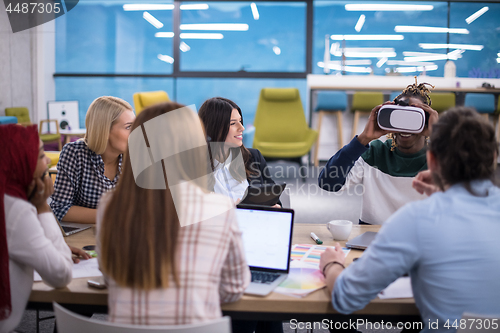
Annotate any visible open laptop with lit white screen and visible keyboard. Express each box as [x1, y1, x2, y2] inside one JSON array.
[[236, 206, 294, 296]]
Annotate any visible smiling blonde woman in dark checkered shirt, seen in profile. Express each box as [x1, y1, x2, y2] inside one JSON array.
[[50, 96, 135, 223]]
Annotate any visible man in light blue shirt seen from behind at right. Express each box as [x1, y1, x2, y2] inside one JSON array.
[[320, 108, 500, 332]]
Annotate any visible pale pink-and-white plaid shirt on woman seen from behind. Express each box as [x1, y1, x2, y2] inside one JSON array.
[[96, 183, 250, 325]]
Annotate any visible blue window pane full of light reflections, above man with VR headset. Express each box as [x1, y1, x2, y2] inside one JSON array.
[[312, 0, 448, 76]]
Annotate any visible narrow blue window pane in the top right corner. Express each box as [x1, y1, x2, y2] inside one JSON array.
[[450, 2, 500, 78]]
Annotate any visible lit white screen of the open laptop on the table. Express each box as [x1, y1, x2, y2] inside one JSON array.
[[236, 208, 293, 270]]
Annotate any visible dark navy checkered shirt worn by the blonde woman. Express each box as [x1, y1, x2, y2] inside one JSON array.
[[50, 141, 122, 221]]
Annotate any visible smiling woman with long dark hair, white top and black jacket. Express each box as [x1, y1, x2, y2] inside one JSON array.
[[198, 97, 279, 207]]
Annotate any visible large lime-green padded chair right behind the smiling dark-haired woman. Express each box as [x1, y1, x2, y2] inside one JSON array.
[[253, 88, 318, 174]]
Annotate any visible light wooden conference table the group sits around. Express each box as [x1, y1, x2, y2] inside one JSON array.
[[29, 224, 419, 321]]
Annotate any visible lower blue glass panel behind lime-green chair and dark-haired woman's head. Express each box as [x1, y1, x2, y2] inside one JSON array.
[[177, 78, 307, 126]]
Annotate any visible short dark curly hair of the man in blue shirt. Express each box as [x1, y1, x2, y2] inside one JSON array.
[[429, 107, 498, 194]]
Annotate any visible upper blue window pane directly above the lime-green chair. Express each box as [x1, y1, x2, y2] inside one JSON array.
[[180, 1, 306, 72]]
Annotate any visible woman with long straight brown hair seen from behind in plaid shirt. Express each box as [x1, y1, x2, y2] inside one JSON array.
[[97, 102, 250, 325]]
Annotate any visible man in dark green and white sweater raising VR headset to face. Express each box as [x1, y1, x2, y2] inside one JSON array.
[[318, 78, 438, 224]]
